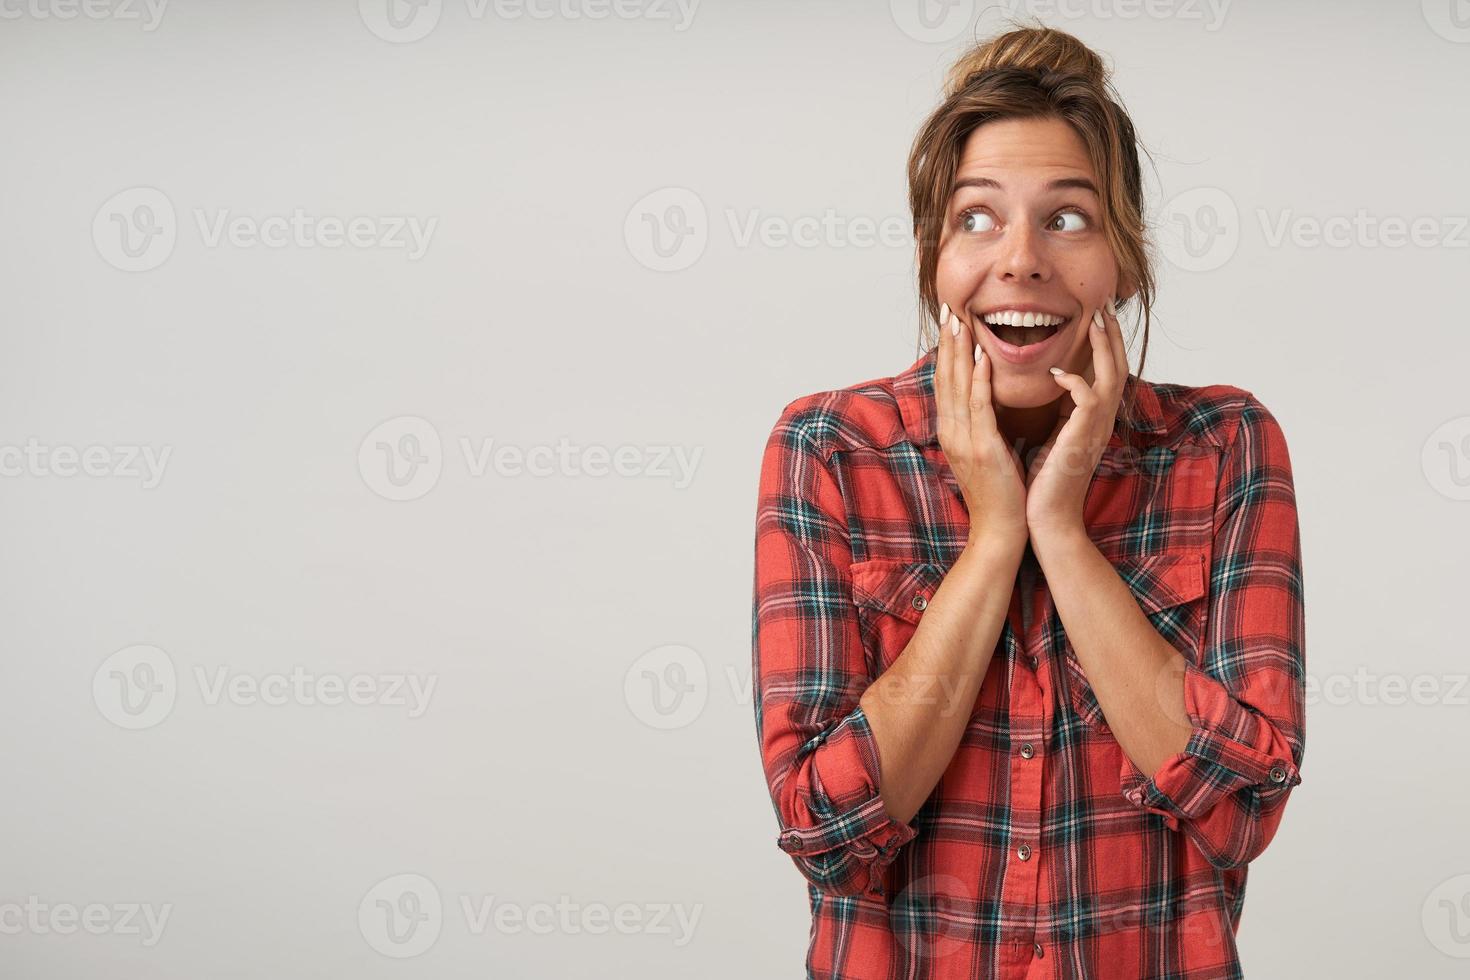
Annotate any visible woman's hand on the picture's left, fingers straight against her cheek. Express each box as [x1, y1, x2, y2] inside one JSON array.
[[933, 304, 1026, 548]]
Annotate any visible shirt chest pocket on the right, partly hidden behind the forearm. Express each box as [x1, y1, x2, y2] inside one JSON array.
[[1061, 550, 1208, 732]]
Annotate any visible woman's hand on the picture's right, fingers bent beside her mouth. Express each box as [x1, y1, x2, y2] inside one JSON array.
[[1026, 307, 1127, 538]]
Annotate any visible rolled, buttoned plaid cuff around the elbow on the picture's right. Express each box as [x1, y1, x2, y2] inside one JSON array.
[[1122, 661, 1301, 830]]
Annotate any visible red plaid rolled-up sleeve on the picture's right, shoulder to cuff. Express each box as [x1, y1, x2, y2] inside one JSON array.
[[1122, 394, 1307, 868]]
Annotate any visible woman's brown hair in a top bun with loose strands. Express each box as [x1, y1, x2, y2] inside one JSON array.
[[908, 26, 1154, 375]]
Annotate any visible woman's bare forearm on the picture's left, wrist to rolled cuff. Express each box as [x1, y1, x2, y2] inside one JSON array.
[[861, 539, 1026, 823]]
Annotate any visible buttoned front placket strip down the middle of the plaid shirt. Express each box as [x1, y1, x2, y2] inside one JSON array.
[[1001, 545, 1054, 977]]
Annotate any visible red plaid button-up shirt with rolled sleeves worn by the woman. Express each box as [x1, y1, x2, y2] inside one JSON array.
[[753, 343, 1305, 980]]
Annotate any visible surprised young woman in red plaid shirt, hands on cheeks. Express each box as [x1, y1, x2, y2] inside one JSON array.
[[753, 22, 1305, 980]]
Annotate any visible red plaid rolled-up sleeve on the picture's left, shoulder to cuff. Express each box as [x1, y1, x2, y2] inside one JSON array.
[[751, 397, 917, 895]]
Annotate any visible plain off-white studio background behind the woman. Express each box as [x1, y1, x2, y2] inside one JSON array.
[[0, 0, 1470, 979]]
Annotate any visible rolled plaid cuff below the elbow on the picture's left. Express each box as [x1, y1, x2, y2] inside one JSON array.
[[776, 704, 919, 871]]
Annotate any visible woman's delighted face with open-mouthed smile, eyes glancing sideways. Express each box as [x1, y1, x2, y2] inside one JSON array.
[[935, 119, 1119, 408]]
